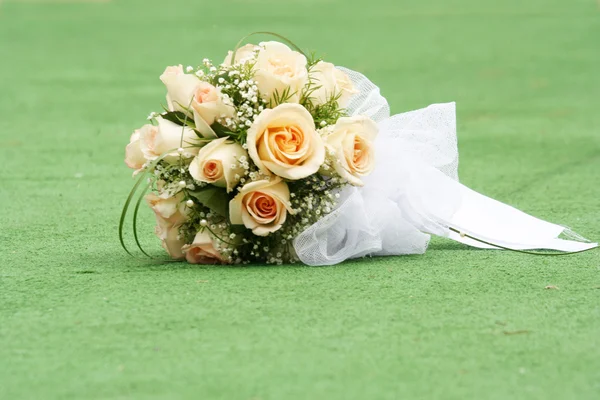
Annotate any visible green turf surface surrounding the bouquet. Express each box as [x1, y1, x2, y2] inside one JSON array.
[[0, 0, 600, 400]]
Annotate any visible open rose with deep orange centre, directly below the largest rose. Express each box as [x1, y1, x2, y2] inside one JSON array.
[[229, 178, 294, 236]]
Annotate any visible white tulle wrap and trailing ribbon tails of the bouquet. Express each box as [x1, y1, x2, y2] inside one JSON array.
[[294, 68, 597, 265]]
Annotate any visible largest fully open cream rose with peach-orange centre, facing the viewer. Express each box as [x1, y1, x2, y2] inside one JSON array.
[[246, 104, 325, 180]]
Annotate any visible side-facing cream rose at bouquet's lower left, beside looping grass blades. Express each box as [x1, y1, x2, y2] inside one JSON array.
[[146, 192, 187, 259]]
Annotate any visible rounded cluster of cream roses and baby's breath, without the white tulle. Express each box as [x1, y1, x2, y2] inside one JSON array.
[[125, 41, 377, 264]]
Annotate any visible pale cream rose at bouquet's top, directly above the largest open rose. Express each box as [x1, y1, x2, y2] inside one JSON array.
[[254, 42, 308, 103]]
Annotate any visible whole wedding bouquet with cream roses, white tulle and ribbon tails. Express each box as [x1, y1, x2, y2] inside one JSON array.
[[120, 35, 595, 265]]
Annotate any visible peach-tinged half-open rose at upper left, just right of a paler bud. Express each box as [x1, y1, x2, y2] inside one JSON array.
[[192, 81, 235, 138]]
